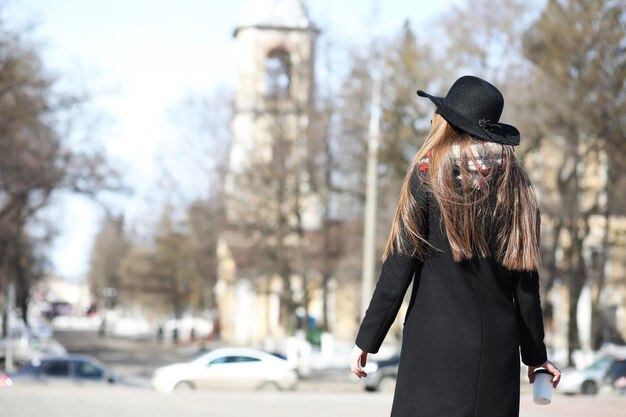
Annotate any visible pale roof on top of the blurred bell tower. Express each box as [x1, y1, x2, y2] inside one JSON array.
[[235, 0, 316, 36]]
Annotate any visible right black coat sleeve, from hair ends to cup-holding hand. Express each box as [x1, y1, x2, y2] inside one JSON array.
[[513, 271, 548, 366]]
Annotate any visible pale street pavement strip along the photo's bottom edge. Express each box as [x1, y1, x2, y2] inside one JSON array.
[[0, 385, 626, 417]]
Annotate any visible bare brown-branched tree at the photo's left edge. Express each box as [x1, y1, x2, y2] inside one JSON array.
[[0, 20, 119, 334]]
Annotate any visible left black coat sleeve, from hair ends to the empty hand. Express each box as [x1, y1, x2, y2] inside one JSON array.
[[356, 254, 419, 353]]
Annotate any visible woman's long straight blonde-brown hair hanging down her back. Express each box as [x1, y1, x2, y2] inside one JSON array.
[[384, 114, 540, 270]]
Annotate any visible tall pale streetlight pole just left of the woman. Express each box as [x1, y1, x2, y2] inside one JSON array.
[[361, 72, 382, 318]]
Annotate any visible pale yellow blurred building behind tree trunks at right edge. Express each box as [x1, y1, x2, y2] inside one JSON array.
[[529, 142, 626, 358]]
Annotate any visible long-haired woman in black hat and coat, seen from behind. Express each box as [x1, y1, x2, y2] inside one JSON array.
[[350, 76, 560, 417]]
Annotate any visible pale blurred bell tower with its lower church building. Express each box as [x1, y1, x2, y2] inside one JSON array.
[[217, 0, 361, 344]]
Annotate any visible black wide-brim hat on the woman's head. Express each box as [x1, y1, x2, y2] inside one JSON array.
[[417, 75, 520, 146]]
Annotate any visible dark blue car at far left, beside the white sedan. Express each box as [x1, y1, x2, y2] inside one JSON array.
[[10, 354, 119, 384]]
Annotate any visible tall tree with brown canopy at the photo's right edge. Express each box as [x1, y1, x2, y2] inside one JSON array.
[[526, 0, 626, 361]]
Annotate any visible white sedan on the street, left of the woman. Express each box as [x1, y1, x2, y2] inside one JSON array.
[[151, 348, 298, 392]]
